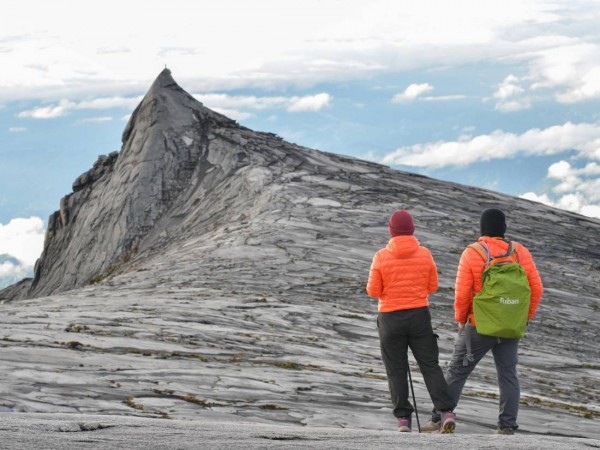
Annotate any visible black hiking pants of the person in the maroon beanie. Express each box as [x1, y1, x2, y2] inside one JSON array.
[[377, 306, 456, 417]]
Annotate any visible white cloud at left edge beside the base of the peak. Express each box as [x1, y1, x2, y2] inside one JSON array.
[[0, 217, 46, 286]]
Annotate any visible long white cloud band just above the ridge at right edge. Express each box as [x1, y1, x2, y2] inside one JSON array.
[[382, 122, 600, 168]]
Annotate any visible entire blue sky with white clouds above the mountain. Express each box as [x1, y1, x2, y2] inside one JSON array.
[[0, 0, 600, 287]]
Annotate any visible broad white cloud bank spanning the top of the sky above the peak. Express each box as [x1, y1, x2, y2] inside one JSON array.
[[0, 0, 598, 110]]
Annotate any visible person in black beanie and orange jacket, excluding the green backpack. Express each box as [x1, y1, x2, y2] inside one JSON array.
[[422, 208, 543, 434]]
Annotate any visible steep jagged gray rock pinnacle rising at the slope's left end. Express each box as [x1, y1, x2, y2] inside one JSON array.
[[11, 68, 246, 296]]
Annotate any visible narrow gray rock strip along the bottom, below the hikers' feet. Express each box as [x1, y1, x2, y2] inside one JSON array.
[[0, 414, 600, 450]]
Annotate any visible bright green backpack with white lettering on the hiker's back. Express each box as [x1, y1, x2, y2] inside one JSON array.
[[469, 241, 531, 338]]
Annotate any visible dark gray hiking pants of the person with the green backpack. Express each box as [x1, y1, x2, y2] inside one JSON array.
[[432, 325, 521, 429]]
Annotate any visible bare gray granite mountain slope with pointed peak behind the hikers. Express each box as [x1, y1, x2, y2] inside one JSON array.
[[0, 71, 600, 438]]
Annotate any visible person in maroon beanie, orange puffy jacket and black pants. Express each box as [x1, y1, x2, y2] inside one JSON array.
[[367, 210, 456, 433]]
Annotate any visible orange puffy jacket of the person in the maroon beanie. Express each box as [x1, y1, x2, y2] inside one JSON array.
[[367, 236, 438, 312]]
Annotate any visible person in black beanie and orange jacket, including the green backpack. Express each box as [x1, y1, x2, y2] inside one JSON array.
[[421, 208, 543, 434]]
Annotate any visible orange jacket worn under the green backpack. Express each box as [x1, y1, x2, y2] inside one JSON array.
[[454, 236, 544, 326]]
